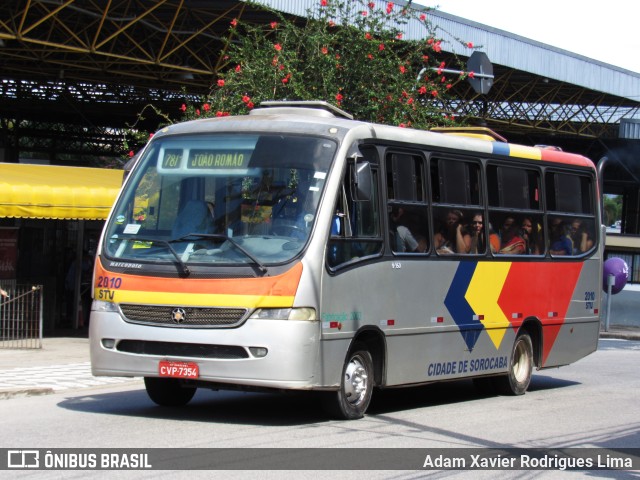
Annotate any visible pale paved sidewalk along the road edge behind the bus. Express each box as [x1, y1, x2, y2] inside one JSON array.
[[0, 325, 640, 399]]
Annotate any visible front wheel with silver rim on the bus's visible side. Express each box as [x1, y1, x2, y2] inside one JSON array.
[[324, 344, 375, 420]]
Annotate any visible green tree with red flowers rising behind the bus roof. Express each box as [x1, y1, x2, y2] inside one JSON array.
[[125, 0, 473, 154]]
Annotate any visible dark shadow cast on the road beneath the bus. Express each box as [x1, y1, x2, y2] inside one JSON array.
[[58, 375, 577, 426]]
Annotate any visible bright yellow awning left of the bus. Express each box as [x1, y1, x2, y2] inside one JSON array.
[[0, 163, 123, 220]]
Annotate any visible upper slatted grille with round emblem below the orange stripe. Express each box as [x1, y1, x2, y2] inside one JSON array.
[[120, 304, 247, 328]]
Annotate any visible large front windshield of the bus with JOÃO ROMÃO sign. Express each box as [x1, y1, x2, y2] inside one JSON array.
[[104, 134, 337, 272]]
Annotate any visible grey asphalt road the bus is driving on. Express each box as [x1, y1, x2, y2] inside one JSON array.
[[0, 339, 640, 479]]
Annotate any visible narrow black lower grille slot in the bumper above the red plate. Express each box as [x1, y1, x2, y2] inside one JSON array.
[[116, 340, 249, 360]]
